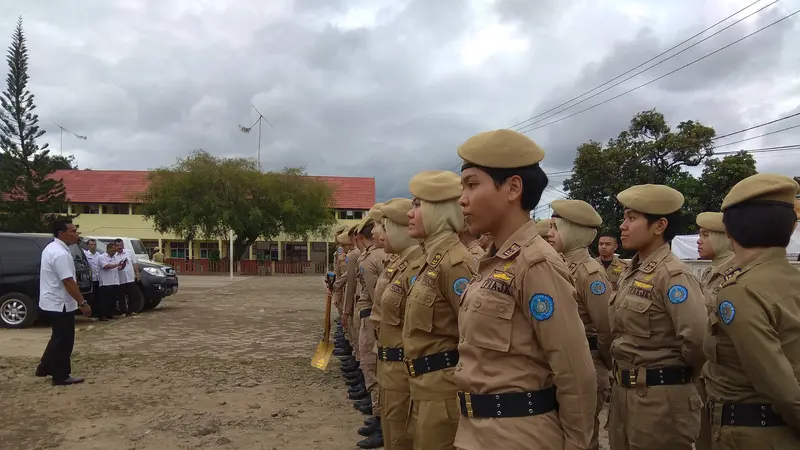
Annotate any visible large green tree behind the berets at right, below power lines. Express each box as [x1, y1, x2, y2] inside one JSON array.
[[564, 110, 756, 239]]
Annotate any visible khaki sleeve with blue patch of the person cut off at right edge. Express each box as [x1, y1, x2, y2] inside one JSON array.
[[717, 284, 800, 430]]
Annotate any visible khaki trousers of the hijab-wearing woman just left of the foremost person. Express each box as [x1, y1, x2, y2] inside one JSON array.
[[408, 398, 460, 450]]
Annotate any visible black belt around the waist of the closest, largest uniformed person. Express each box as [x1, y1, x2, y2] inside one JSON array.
[[458, 387, 558, 417]]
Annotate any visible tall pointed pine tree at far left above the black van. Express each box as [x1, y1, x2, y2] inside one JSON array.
[[0, 17, 67, 233]]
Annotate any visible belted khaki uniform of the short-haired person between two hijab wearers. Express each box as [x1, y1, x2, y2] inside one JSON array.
[[608, 244, 706, 450]]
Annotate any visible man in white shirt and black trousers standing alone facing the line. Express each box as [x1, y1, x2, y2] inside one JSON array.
[[36, 219, 92, 385]]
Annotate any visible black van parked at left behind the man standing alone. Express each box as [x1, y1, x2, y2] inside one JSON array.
[[0, 233, 92, 328]]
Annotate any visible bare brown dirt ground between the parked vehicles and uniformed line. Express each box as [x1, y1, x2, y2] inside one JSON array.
[[0, 276, 607, 450]]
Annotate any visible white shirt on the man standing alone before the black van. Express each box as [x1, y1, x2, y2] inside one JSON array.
[[39, 239, 78, 312]]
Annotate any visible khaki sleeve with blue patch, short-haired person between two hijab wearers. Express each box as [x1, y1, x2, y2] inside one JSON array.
[[664, 272, 708, 377]]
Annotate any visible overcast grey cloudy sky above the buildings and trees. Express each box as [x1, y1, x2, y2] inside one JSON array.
[[0, 0, 800, 201]]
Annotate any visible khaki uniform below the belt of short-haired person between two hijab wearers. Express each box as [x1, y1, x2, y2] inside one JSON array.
[[608, 380, 703, 450]]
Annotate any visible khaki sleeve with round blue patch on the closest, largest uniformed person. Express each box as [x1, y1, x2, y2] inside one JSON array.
[[522, 261, 597, 450]]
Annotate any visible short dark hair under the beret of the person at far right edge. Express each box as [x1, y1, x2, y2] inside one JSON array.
[[722, 202, 797, 248]]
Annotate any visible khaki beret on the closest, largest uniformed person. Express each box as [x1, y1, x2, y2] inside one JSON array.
[[458, 130, 544, 169]]
